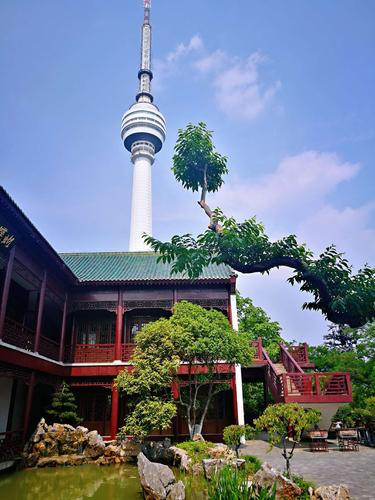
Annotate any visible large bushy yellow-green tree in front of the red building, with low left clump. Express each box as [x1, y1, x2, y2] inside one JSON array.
[[116, 301, 253, 437]]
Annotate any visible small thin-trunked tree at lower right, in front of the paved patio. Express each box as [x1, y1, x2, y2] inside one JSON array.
[[254, 403, 320, 476]]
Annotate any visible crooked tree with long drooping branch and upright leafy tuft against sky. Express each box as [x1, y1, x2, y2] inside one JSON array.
[[145, 123, 375, 327]]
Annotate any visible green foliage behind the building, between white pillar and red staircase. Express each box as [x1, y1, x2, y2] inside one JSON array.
[[237, 292, 285, 360]]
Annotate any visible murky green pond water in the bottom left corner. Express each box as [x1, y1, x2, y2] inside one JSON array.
[[0, 465, 143, 500]]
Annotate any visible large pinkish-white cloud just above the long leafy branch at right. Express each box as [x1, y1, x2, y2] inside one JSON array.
[[215, 151, 360, 218]]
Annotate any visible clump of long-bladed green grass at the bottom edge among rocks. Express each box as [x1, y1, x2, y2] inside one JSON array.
[[208, 466, 276, 500]]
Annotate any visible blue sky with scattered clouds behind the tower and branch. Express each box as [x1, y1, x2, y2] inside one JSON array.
[[0, 0, 375, 344]]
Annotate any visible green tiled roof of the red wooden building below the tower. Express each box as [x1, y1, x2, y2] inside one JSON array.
[[60, 252, 234, 282]]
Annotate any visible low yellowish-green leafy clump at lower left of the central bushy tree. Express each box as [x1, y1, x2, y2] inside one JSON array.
[[119, 398, 176, 442]]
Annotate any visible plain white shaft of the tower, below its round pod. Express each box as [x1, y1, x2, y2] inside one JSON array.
[[129, 141, 155, 252]]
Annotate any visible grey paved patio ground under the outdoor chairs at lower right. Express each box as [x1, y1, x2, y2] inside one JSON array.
[[240, 440, 375, 500]]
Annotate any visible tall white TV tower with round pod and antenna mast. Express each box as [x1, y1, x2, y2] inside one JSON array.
[[121, 0, 166, 252]]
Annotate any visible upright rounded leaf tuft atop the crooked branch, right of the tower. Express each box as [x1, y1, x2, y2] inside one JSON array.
[[172, 122, 228, 196]]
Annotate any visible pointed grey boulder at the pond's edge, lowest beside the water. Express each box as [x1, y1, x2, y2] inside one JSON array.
[[138, 452, 185, 500]]
